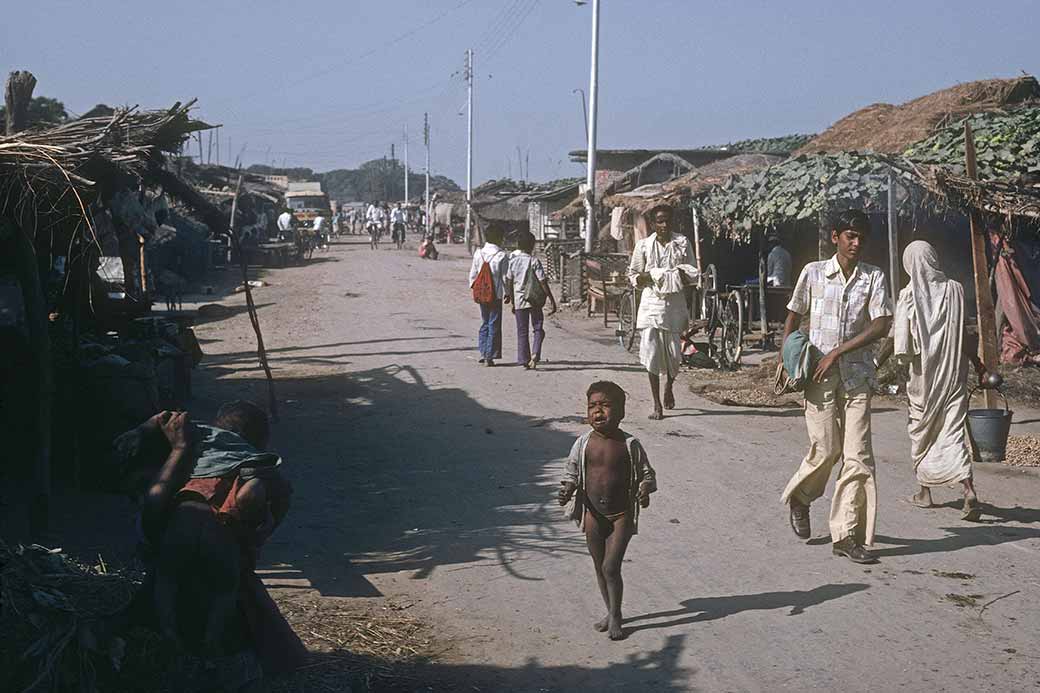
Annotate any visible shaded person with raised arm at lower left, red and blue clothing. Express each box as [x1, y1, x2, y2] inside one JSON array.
[[115, 402, 306, 674]]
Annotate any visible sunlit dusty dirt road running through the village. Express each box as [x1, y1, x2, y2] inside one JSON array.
[[189, 236, 1040, 691]]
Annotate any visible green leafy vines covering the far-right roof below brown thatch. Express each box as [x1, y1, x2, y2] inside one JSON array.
[[904, 106, 1040, 180]]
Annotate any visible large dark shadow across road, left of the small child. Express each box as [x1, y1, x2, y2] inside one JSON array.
[[192, 366, 584, 596]]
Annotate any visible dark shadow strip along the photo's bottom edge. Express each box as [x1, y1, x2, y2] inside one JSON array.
[[271, 635, 697, 693]]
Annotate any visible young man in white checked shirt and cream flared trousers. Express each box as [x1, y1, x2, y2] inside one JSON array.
[[782, 209, 892, 563]]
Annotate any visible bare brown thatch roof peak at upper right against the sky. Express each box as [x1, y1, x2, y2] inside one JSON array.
[[796, 75, 1040, 154]]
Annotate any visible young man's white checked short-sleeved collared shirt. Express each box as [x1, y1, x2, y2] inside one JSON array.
[[787, 255, 892, 391]]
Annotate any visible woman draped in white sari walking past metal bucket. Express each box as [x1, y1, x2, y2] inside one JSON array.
[[894, 240, 985, 520]]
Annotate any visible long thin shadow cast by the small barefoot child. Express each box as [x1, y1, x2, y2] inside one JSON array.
[[625, 583, 869, 635]]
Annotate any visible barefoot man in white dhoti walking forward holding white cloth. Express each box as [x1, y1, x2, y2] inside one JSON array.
[[628, 205, 697, 420]]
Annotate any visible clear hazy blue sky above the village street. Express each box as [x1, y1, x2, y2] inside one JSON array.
[[6, 0, 1040, 183]]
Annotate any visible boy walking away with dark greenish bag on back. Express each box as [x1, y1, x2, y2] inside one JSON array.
[[505, 231, 556, 369]]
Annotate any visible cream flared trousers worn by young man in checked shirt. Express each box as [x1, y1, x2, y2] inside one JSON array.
[[782, 375, 878, 545]]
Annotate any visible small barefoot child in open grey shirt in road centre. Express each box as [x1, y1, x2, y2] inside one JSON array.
[[558, 381, 657, 640]]
